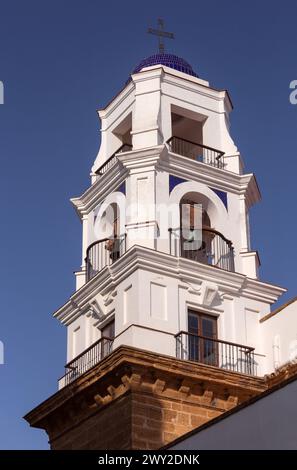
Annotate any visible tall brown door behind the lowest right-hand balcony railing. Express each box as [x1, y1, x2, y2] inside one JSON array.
[[188, 310, 218, 366]]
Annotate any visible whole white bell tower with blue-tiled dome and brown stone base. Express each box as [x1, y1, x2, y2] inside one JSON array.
[[26, 53, 285, 449]]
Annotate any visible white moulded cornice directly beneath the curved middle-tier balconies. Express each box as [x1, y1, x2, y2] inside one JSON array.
[[54, 245, 285, 325]]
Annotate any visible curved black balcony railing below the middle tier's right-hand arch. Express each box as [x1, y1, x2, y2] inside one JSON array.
[[169, 228, 234, 271]]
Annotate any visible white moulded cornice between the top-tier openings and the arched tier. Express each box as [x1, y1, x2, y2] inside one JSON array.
[[71, 144, 261, 217]]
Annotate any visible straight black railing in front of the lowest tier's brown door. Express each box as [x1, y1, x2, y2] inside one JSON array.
[[175, 331, 257, 375]]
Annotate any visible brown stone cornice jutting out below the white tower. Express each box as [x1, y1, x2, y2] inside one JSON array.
[[24, 345, 267, 429]]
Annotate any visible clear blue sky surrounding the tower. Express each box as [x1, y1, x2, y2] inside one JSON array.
[[0, 0, 297, 449]]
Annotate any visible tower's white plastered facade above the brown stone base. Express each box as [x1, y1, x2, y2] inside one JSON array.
[[55, 57, 297, 386]]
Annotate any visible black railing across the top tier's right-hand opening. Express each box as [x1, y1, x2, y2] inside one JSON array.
[[167, 137, 224, 168]]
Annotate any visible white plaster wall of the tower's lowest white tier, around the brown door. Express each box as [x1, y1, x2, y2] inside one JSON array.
[[63, 250, 280, 375]]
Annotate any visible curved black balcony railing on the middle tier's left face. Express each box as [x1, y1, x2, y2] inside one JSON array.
[[86, 234, 126, 281]]
